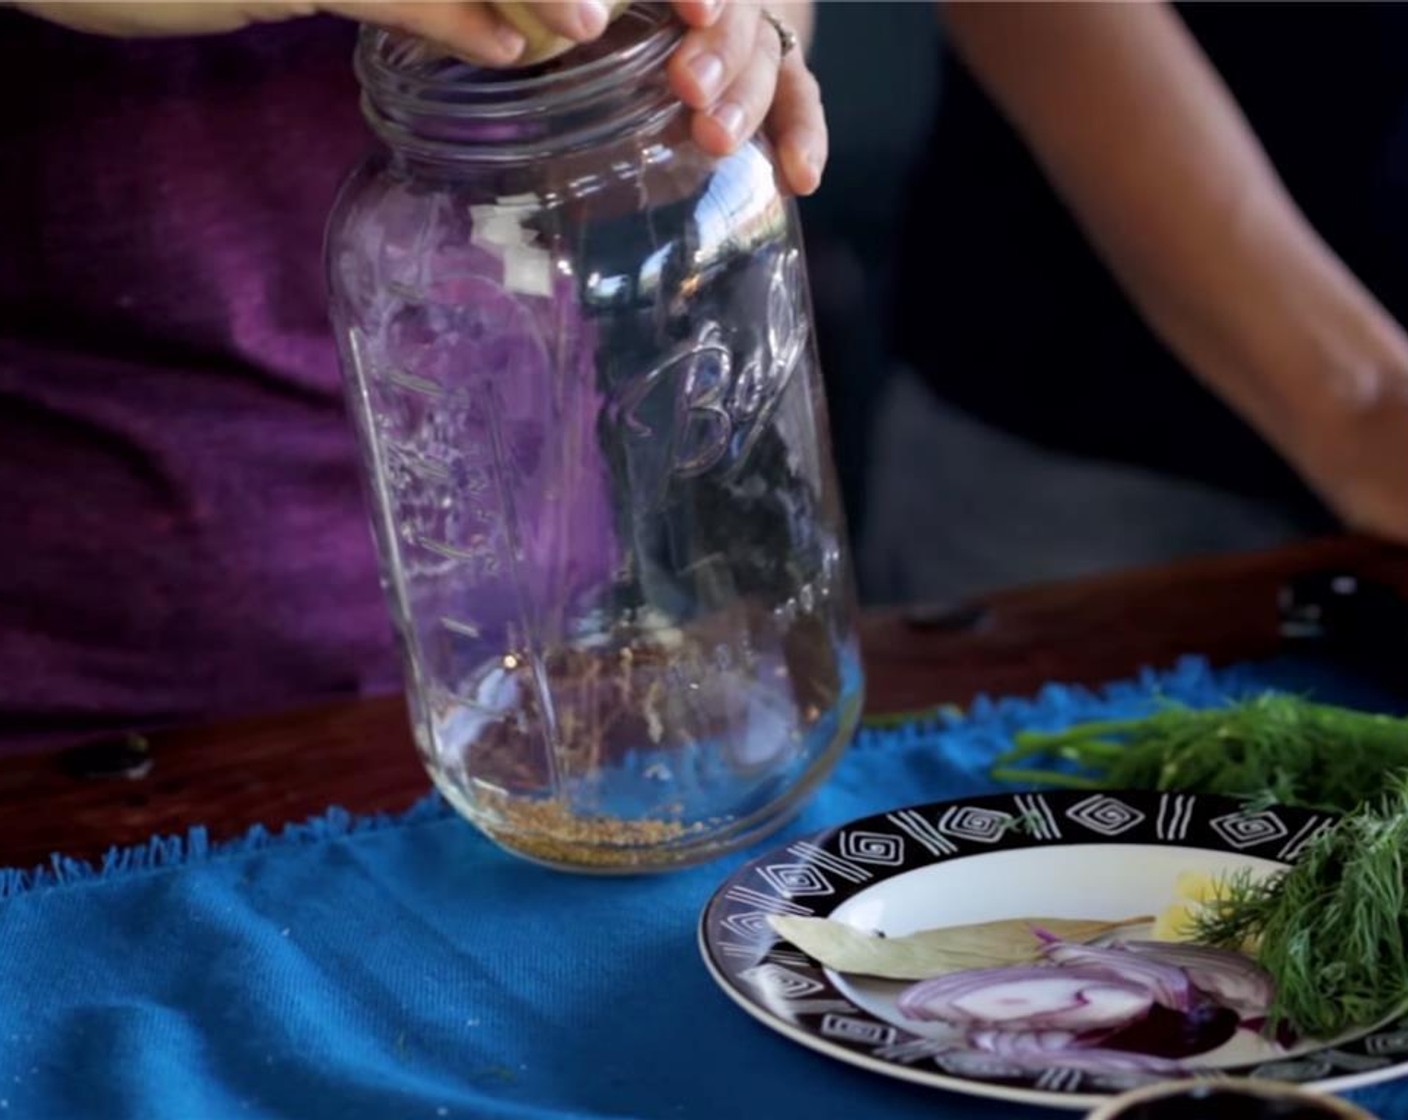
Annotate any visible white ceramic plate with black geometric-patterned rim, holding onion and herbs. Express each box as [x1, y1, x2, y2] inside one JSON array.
[[700, 792, 1408, 1109]]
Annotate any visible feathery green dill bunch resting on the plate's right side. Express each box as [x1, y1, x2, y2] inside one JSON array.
[[1194, 775, 1408, 1038]]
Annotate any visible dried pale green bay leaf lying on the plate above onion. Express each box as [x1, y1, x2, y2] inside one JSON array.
[[767, 914, 1153, 981]]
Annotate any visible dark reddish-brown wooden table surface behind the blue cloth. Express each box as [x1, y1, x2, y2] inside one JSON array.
[[0, 538, 1408, 866]]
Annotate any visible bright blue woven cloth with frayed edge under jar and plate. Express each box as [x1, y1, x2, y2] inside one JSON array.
[[0, 661, 1408, 1120]]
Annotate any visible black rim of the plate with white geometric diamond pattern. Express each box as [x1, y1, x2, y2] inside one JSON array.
[[701, 790, 1408, 1097]]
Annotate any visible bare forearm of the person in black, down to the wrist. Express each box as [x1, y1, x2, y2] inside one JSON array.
[[948, 3, 1408, 449]]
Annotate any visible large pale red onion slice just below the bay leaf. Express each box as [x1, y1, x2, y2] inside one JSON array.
[[898, 965, 1153, 1034]]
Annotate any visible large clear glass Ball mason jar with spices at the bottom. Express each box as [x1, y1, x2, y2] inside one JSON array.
[[327, 6, 862, 871]]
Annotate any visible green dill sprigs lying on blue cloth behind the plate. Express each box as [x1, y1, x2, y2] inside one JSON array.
[[993, 693, 1408, 813]]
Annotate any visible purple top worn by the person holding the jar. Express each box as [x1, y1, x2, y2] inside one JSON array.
[[0, 11, 397, 749]]
